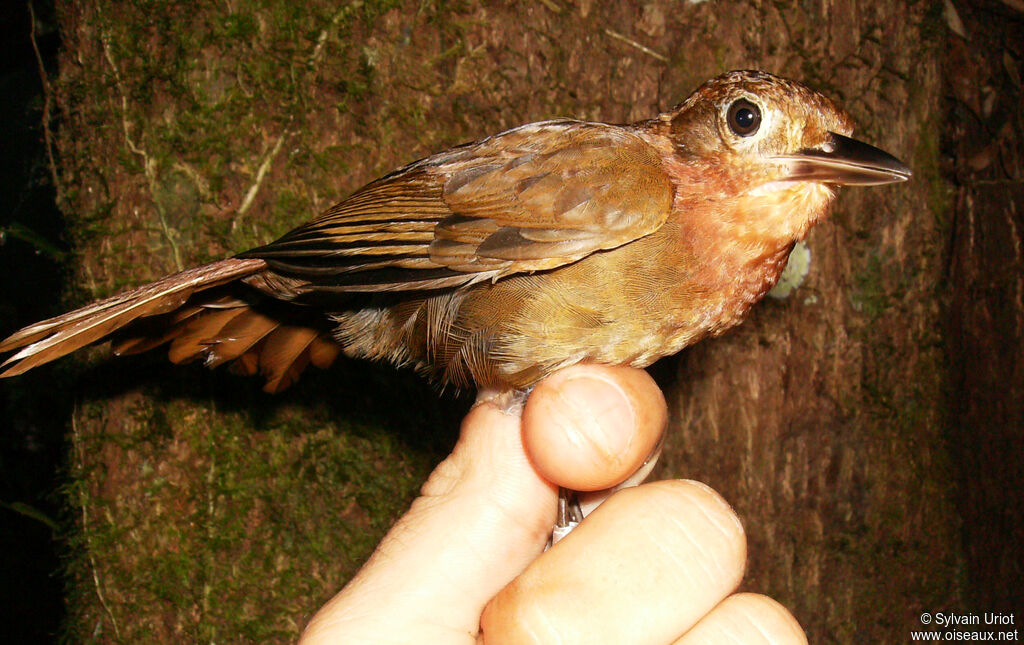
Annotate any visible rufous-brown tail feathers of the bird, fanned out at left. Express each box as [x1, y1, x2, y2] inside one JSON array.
[[0, 258, 340, 391]]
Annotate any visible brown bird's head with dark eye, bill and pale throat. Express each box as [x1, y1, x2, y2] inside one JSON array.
[[658, 71, 910, 239]]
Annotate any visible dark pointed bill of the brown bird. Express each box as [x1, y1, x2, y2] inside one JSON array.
[[776, 132, 912, 186]]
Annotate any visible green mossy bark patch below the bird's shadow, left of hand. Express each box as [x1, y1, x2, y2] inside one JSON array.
[[66, 380, 430, 642]]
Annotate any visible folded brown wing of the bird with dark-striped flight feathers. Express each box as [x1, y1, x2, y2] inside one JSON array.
[[240, 121, 674, 295]]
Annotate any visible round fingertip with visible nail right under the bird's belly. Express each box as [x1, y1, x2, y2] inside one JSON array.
[[522, 364, 669, 490]]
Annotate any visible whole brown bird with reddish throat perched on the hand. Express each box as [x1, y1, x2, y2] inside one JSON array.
[[0, 71, 911, 393]]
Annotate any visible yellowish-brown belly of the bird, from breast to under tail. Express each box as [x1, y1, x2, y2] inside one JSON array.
[[335, 225, 788, 389]]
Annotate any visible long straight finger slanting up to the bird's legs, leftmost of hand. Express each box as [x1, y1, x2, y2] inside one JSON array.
[[302, 403, 556, 644]]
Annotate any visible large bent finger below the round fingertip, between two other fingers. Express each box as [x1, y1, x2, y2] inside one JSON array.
[[481, 481, 746, 645]]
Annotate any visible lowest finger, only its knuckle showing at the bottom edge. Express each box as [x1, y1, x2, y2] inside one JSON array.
[[673, 594, 807, 645]]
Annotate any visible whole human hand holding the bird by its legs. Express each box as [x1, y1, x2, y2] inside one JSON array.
[[302, 366, 806, 645]]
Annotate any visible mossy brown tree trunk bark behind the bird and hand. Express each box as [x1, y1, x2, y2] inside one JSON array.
[[22, 0, 1015, 643]]
